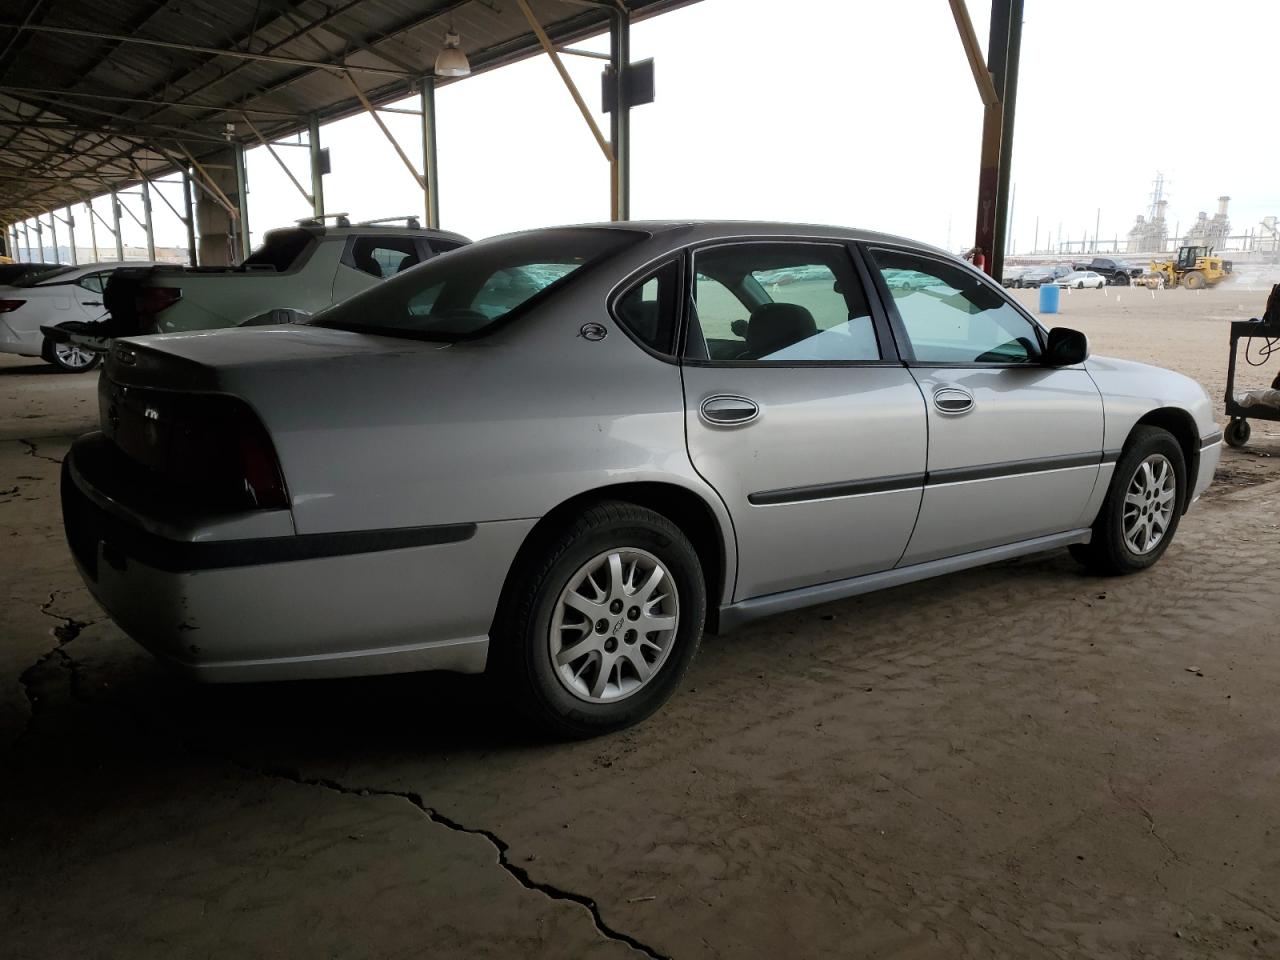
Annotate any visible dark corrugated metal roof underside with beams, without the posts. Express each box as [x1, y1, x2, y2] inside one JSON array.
[[0, 0, 694, 223]]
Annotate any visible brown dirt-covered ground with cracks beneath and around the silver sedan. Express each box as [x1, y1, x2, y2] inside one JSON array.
[[0, 278, 1280, 960]]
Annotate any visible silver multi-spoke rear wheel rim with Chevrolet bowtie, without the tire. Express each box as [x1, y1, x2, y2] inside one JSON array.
[[548, 548, 680, 703]]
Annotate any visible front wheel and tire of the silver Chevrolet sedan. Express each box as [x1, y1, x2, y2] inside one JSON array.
[[1070, 426, 1187, 576]]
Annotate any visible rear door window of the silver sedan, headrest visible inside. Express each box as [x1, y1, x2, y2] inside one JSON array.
[[687, 243, 879, 362]]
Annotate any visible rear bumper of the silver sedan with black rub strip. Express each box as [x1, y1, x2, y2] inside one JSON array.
[[61, 438, 534, 681]]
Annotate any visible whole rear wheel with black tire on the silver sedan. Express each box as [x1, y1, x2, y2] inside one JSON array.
[[493, 502, 707, 737]]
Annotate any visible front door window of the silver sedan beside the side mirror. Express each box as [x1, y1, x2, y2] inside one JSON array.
[[873, 250, 1041, 364]]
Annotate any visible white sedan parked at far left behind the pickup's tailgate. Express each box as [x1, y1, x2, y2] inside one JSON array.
[[0, 262, 154, 374]]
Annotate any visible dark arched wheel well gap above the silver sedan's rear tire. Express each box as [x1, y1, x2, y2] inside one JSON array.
[[491, 483, 726, 630]]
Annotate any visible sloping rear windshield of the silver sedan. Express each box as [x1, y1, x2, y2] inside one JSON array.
[[310, 227, 644, 342]]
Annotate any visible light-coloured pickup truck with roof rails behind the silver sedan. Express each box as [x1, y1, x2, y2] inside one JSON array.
[[45, 220, 470, 352]]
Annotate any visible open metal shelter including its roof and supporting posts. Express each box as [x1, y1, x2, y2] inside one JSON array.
[[0, 0, 1023, 274]]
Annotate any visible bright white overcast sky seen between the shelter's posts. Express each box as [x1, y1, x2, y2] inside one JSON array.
[[12, 0, 1280, 259]]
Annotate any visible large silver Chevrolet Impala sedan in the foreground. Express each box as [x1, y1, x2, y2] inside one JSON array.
[[63, 223, 1221, 736]]
